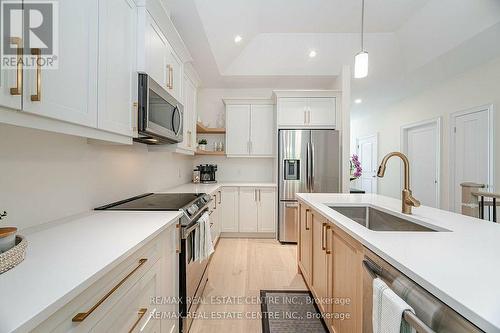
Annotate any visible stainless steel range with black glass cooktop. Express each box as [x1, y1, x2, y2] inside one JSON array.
[[96, 193, 212, 333]]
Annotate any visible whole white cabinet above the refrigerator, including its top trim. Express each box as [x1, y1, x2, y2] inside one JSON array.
[[275, 91, 340, 129]]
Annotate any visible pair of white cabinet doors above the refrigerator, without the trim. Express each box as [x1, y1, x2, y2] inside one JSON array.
[[278, 97, 336, 128]]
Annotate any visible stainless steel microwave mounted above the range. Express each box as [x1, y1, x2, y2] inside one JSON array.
[[134, 73, 184, 144]]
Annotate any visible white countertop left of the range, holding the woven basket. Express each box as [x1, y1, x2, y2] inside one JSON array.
[[0, 211, 181, 333]]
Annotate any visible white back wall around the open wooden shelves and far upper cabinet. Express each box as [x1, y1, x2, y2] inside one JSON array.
[[194, 88, 275, 182]]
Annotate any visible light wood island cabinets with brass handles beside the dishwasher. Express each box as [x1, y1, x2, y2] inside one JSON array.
[[297, 203, 364, 333]]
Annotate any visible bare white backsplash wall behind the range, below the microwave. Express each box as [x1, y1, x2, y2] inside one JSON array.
[[0, 124, 193, 228]]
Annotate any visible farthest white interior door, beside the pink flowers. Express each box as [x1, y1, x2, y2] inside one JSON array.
[[357, 135, 378, 193]]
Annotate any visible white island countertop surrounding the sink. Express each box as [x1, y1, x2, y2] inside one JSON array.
[[297, 193, 500, 332]]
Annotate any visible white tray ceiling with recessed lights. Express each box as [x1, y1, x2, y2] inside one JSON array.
[[163, 0, 500, 108]]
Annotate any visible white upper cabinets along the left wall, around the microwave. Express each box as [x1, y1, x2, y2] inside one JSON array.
[[0, 0, 192, 145]]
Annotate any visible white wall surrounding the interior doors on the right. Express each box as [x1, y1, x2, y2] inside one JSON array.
[[351, 56, 500, 209]]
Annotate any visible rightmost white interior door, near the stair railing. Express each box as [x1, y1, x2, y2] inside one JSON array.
[[450, 108, 493, 212]]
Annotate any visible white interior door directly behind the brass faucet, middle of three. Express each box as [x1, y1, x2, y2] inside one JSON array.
[[402, 119, 441, 208]]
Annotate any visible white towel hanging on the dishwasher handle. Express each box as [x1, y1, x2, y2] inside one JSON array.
[[372, 278, 415, 333]]
